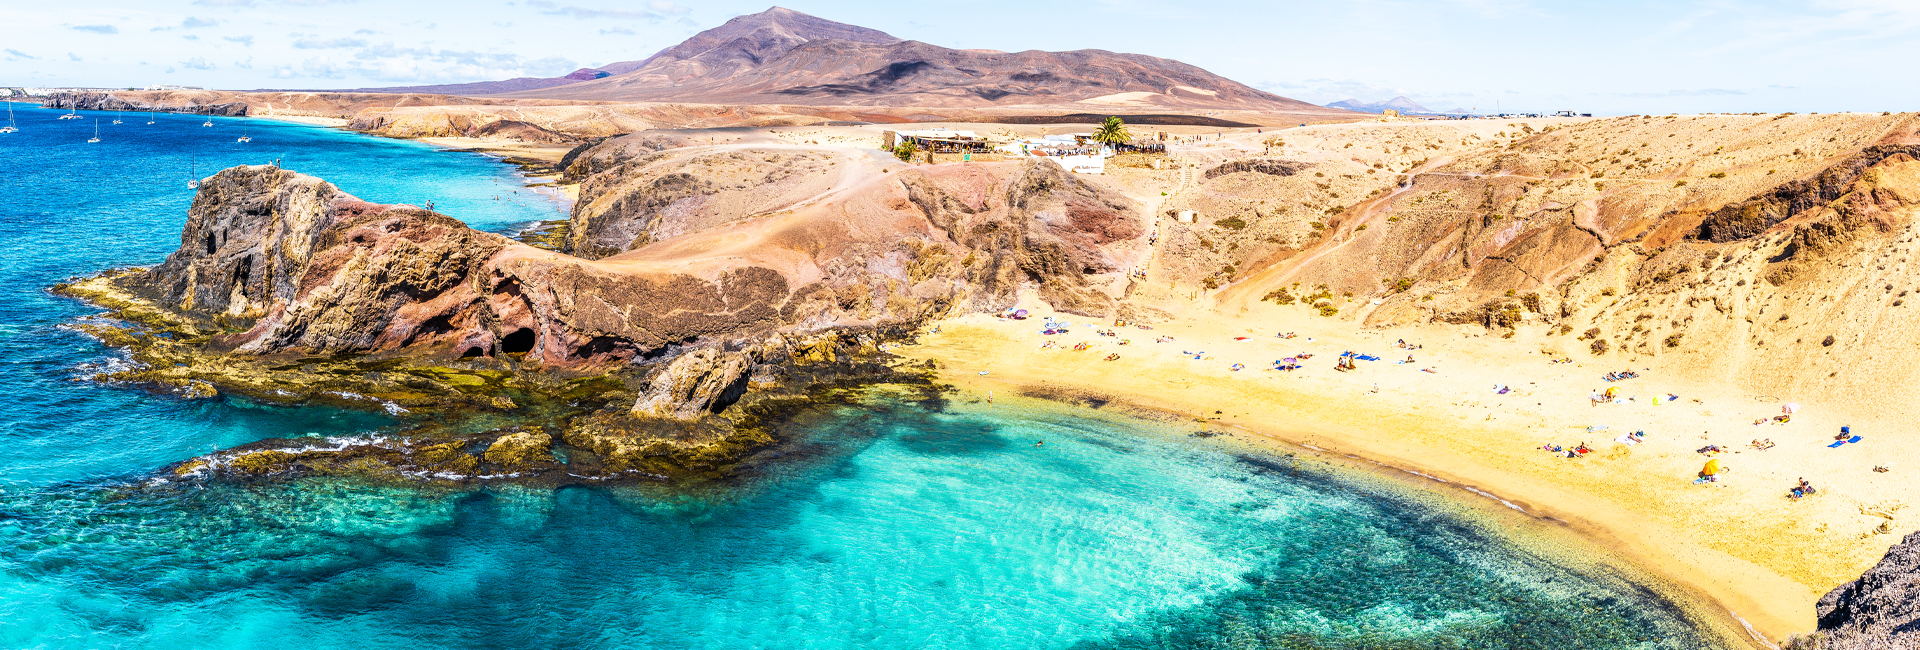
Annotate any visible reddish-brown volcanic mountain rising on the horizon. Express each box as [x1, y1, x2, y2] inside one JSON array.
[[388, 8, 1327, 113]]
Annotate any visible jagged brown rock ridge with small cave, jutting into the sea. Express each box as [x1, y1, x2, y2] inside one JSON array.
[[127, 167, 789, 366]]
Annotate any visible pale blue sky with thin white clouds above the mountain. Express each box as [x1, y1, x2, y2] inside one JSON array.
[[0, 0, 1920, 115]]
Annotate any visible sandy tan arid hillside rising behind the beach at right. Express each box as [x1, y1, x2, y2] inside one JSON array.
[[1142, 115, 1920, 406]]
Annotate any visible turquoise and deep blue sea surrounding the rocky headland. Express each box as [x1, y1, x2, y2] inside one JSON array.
[[0, 104, 1707, 650]]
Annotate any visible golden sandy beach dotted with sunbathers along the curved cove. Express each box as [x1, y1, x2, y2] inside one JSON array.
[[900, 303, 1916, 642]]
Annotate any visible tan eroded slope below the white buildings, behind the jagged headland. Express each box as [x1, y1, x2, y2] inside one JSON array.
[[566, 134, 1148, 320]]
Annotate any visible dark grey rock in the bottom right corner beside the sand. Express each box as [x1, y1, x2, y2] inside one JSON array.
[[1789, 533, 1920, 650]]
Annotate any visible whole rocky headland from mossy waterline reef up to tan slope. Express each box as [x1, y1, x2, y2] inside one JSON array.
[[60, 148, 1142, 477]]
